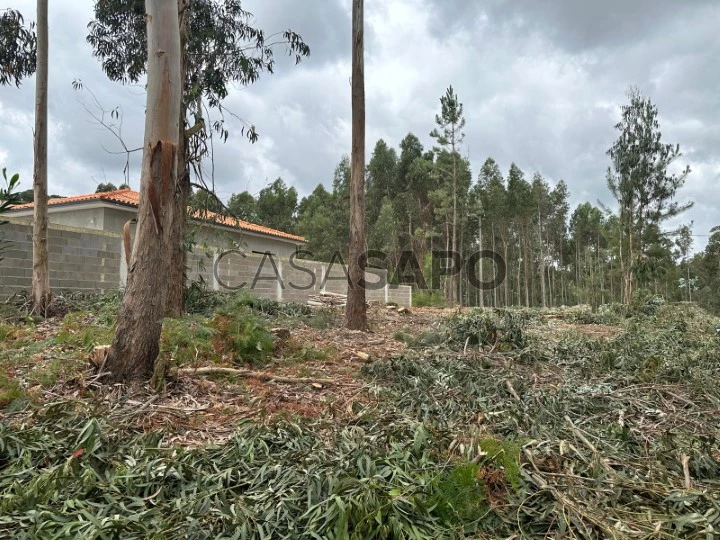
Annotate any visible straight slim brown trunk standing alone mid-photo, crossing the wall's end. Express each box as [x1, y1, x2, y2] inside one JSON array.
[[346, 0, 367, 330]]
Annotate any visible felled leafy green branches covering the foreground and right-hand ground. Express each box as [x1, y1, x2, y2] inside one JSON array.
[[0, 305, 720, 540]]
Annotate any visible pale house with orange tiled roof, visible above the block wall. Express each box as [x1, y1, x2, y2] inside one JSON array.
[[6, 189, 305, 258]]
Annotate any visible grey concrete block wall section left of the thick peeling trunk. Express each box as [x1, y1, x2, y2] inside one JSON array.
[[0, 219, 122, 299]]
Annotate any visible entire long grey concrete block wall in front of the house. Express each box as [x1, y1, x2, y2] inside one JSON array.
[[0, 218, 412, 307]]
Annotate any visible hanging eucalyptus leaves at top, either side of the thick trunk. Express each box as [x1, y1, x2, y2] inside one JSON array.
[[87, 0, 310, 152]]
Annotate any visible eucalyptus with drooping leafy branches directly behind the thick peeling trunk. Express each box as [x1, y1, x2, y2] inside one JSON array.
[[87, 0, 310, 313]]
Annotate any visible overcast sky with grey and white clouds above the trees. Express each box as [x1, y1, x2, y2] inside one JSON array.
[[0, 0, 720, 249]]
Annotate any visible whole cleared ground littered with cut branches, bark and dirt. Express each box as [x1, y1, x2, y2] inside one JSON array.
[[0, 296, 720, 539]]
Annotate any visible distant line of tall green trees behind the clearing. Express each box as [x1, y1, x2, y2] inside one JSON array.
[[196, 87, 714, 307]]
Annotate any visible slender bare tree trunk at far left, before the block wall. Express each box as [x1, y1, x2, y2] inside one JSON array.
[[32, 0, 52, 315]]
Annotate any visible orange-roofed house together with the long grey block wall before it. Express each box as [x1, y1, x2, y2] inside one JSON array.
[[0, 189, 412, 306]]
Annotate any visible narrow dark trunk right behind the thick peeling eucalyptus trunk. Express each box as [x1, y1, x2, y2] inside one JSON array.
[[165, 0, 190, 317]]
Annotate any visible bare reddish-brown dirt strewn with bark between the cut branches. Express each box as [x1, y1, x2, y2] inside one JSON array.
[[2, 306, 617, 446]]
